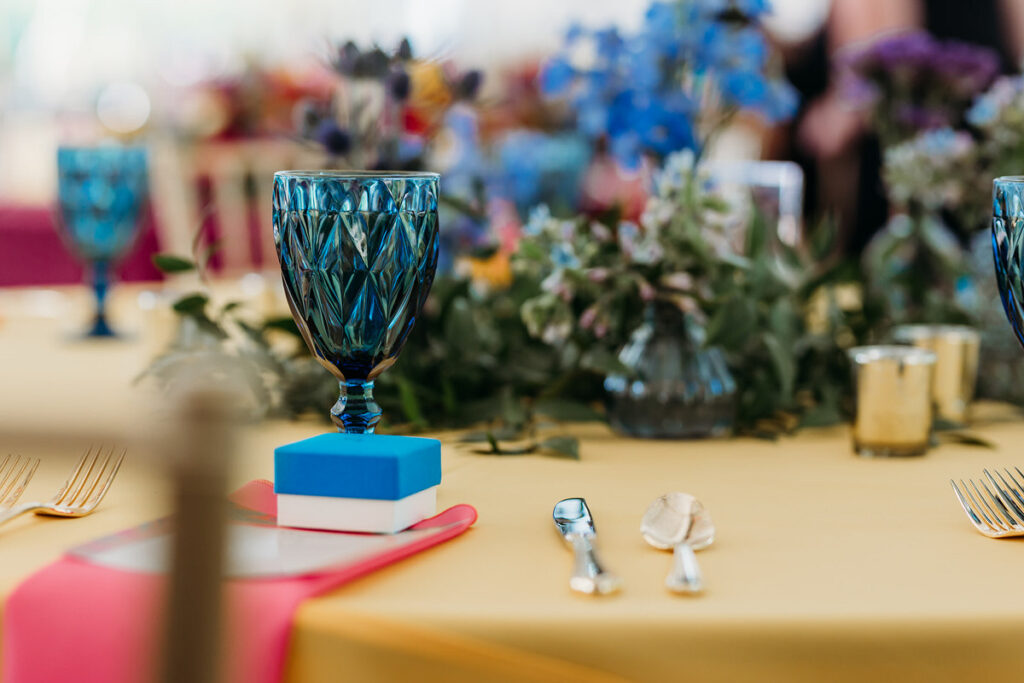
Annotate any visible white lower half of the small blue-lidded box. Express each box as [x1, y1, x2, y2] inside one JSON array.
[[278, 486, 437, 533]]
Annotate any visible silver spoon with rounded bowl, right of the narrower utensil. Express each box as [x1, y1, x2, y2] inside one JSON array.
[[640, 492, 715, 593]]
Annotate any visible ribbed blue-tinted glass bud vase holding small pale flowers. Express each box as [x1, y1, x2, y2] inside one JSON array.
[[604, 301, 736, 438]]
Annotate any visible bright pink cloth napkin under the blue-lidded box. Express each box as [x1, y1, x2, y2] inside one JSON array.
[[0, 480, 476, 683]]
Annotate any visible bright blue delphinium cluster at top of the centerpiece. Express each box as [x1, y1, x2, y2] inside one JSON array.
[[540, 0, 797, 167]]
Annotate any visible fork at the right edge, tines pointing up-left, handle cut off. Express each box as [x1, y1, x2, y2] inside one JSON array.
[[949, 467, 1024, 539]]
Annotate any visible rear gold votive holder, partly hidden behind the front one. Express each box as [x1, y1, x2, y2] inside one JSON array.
[[892, 325, 981, 427]]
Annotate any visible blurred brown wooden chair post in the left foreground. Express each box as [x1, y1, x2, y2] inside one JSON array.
[[161, 391, 234, 683]]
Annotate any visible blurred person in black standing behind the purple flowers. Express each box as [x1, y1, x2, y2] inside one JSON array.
[[786, 0, 1024, 255]]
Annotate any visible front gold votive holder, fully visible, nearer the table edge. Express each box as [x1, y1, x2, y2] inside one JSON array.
[[849, 346, 936, 457]]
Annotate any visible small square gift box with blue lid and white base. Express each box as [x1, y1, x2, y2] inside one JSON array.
[[273, 434, 441, 533]]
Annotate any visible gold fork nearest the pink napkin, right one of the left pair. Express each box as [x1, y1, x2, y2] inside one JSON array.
[[0, 449, 125, 524]]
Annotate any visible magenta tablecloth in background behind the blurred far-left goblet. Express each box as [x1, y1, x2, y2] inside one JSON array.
[[0, 204, 161, 287]]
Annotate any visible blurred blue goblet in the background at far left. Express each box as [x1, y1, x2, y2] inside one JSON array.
[[57, 145, 148, 337]]
